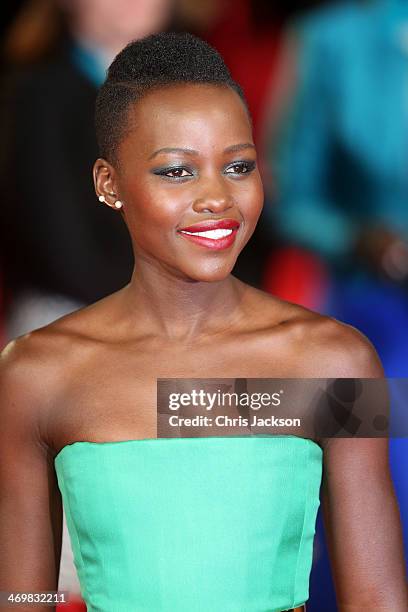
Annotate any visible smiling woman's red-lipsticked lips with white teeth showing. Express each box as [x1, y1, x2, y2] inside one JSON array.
[[178, 219, 240, 250]]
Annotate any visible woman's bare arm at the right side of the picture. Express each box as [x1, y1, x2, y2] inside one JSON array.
[[322, 331, 408, 612]]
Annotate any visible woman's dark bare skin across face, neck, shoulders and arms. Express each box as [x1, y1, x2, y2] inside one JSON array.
[[0, 84, 408, 612]]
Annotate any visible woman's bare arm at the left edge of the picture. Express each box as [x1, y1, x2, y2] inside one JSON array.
[[0, 341, 62, 612]]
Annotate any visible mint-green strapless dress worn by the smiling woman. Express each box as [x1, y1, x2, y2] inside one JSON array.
[[55, 435, 323, 612]]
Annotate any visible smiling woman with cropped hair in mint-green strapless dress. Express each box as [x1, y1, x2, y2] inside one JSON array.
[[0, 34, 407, 612]]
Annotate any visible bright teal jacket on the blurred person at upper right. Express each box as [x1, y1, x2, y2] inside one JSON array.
[[267, 0, 408, 267]]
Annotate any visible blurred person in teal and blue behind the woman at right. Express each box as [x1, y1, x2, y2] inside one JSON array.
[[265, 0, 408, 608]]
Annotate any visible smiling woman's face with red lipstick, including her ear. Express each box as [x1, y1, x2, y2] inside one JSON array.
[[95, 84, 263, 281]]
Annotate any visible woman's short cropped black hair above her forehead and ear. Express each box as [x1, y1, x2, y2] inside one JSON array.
[[95, 32, 249, 163]]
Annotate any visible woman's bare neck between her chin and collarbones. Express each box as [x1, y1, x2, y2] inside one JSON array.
[[124, 262, 245, 343]]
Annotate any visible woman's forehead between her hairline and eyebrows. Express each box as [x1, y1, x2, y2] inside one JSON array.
[[119, 84, 252, 157]]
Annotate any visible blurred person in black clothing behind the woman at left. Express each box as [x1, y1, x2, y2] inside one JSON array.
[[0, 0, 173, 338]]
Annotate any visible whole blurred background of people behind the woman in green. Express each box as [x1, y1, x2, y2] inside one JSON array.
[[0, 0, 408, 612]]
